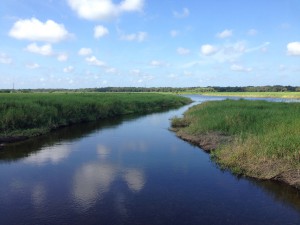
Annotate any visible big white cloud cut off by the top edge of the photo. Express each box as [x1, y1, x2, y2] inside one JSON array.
[[68, 0, 144, 20]]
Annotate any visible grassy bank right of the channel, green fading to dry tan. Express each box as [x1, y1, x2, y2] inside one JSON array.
[[172, 100, 300, 188]]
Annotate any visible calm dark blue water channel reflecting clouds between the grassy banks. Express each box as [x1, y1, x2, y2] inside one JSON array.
[[0, 96, 300, 225]]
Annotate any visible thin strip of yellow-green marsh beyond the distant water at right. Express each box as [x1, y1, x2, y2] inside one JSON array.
[[200, 92, 300, 99]]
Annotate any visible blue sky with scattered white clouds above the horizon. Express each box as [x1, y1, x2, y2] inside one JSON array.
[[0, 0, 300, 88]]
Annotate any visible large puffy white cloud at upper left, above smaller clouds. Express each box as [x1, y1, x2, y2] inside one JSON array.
[[9, 18, 70, 42]]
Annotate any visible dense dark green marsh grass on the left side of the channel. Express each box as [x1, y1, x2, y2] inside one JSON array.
[[0, 93, 190, 142]]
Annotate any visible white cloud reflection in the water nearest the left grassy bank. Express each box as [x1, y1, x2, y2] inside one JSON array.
[[24, 145, 71, 165]]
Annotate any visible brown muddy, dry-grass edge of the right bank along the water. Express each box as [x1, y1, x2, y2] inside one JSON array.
[[171, 127, 300, 189]]
